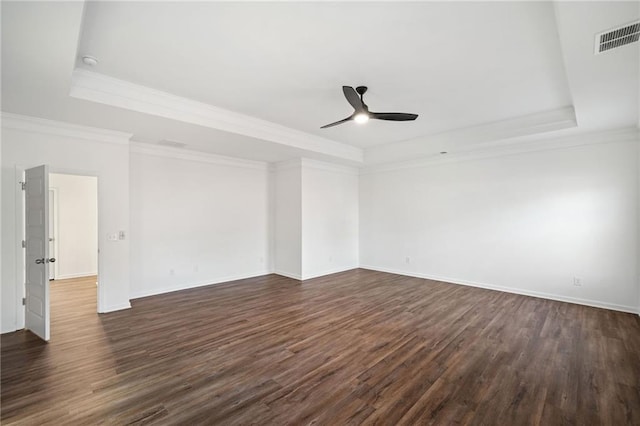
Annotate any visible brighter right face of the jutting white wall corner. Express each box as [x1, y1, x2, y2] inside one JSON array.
[[302, 159, 359, 279]]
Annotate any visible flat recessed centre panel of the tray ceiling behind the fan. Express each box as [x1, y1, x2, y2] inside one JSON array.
[[79, 2, 571, 147]]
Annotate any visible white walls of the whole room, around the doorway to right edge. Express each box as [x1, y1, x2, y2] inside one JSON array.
[[0, 115, 640, 332]]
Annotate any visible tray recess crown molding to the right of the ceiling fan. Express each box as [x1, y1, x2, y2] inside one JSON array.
[[365, 106, 577, 164]]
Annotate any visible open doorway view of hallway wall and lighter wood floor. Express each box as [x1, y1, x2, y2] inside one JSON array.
[[49, 173, 98, 337]]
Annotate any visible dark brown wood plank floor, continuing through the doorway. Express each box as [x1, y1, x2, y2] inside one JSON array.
[[1, 270, 640, 425]]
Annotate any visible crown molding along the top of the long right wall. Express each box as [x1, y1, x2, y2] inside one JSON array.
[[360, 128, 640, 175]]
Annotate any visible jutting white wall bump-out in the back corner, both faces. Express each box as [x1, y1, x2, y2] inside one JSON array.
[[272, 158, 359, 280]]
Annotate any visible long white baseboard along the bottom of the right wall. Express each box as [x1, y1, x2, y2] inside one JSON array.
[[360, 265, 640, 314]]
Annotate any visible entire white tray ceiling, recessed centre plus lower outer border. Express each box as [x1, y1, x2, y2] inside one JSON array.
[[2, 1, 640, 163]]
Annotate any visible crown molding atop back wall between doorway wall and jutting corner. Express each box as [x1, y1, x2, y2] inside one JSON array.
[[130, 142, 268, 171]]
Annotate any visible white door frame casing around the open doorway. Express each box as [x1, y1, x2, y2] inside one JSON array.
[[14, 164, 106, 330]]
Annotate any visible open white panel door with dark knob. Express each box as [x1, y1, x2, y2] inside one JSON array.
[[25, 166, 55, 340]]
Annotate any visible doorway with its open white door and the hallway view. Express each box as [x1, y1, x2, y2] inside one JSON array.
[[22, 165, 100, 341]]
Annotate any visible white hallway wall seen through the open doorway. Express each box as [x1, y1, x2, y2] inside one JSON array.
[[49, 173, 98, 280]]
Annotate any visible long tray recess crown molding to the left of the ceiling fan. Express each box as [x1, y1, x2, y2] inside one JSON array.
[[69, 68, 363, 163]]
